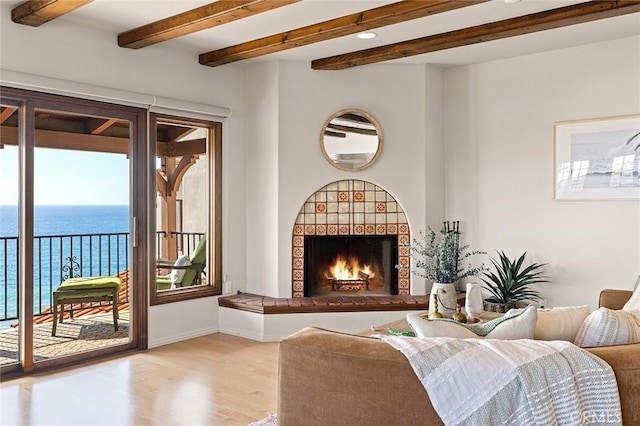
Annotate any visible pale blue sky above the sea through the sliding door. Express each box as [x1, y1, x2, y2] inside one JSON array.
[[0, 146, 129, 205]]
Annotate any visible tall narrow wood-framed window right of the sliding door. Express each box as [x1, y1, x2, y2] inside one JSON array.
[[150, 113, 222, 305]]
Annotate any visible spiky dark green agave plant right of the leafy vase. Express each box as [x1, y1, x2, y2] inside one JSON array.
[[482, 251, 549, 313]]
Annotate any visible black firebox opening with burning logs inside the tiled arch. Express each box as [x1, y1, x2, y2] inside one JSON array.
[[304, 235, 398, 297]]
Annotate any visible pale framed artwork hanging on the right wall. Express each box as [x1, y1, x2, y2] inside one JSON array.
[[553, 115, 640, 200]]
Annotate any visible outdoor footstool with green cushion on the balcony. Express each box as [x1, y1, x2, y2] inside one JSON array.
[[51, 256, 122, 336]]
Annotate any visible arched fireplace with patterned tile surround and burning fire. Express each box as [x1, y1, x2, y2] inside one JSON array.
[[291, 180, 410, 297]]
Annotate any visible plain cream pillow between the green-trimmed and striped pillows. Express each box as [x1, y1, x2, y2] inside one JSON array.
[[534, 305, 590, 342]]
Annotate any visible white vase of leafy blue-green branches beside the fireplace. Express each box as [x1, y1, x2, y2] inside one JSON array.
[[400, 221, 485, 317]]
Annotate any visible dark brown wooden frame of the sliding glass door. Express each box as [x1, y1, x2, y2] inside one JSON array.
[[0, 86, 149, 375]]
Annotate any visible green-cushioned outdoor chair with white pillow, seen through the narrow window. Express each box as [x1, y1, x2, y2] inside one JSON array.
[[156, 237, 207, 290]]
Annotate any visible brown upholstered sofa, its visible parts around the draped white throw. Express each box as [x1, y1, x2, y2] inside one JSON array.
[[277, 290, 640, 426]]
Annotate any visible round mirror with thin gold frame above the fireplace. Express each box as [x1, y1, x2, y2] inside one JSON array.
[[320, 109, 382, 172]]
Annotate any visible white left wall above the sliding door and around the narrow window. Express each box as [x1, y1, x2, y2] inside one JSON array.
[[0, 2, 246, 346]]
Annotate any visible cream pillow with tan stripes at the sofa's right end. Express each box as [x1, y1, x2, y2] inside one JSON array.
[[573, 308, 640, 348]]
